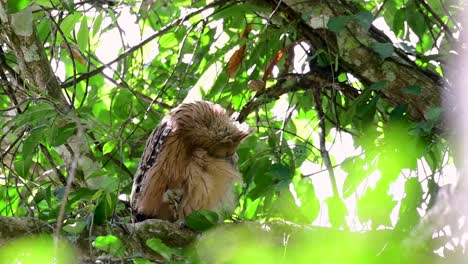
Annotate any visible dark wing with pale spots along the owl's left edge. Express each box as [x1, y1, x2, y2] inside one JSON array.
[[130, 119, 172, 213]]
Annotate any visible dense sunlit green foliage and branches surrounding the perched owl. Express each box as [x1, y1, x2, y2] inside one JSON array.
[[0, 0, 466, 263]]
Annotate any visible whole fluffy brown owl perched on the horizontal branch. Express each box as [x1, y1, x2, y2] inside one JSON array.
[[130, 101, 249, 222]]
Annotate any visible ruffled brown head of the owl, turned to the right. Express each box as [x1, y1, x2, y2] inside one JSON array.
[[171, 101, 250, 158]]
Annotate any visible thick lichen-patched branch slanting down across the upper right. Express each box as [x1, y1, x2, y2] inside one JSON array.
[[266, 0, 442, 121]]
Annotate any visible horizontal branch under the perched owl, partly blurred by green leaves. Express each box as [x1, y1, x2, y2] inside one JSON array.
[[0, 217, 443, 263]]
